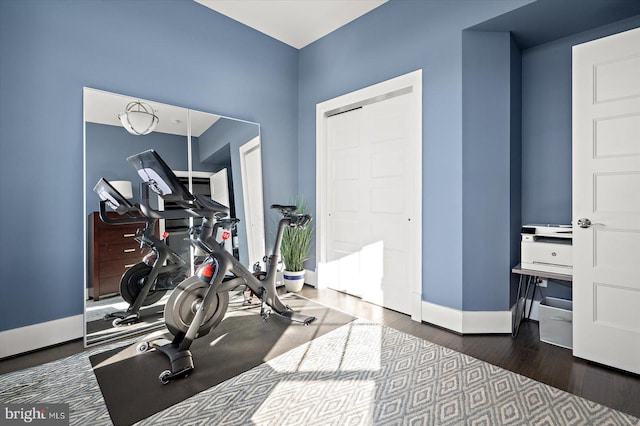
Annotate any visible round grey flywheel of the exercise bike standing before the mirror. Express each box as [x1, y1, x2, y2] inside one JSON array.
[[164, 276, 229, 337]]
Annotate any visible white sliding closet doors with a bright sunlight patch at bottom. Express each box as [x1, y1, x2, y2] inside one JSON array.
[[326, 94, 421, 314]]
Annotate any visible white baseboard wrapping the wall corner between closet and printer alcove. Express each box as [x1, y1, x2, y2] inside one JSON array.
[[422, 301, 511, 334]]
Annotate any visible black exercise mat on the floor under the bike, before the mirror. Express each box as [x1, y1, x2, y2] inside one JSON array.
[[89, 294, 355, 426]]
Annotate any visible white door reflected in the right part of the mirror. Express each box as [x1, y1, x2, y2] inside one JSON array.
[[240, 136, 266, 266]]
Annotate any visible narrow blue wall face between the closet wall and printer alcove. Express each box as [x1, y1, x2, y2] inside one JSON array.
[[462, 31, 520, 311]]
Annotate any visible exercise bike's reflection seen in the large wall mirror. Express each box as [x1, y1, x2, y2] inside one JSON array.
[[93, 178, 195, 327]]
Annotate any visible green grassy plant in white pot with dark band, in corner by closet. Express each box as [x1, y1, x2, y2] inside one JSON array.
[[280, 201, 313, 292]]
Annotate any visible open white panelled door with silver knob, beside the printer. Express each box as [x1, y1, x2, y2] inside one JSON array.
[[573, 29, 640, 373]]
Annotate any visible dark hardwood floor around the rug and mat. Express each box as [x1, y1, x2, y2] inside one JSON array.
[[0, 286, 640, 418]]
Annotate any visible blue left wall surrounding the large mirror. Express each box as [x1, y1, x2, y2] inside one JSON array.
[[0, 0, 298, 330]]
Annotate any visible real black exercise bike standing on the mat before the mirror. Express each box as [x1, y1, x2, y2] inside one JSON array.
[[127, 150, 315, 384]]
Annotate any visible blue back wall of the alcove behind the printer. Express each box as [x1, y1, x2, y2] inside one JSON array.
[[522, 15, 640, 298]]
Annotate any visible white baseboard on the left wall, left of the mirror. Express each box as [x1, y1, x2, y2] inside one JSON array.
[[0, 315, 84, 359]]
